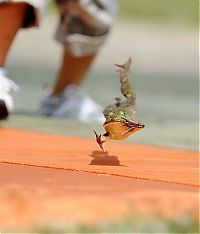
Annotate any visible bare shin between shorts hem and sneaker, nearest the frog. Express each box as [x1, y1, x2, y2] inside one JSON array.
[[52, 50, 95, 96]]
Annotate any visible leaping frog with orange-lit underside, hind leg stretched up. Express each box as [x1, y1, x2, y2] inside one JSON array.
[[94, 57, 145, 152]]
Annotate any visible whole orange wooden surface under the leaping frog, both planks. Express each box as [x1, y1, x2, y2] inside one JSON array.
[[0, 128, 199, 231]]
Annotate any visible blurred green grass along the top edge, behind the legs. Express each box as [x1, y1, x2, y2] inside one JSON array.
[[49, 0, 199, 26]]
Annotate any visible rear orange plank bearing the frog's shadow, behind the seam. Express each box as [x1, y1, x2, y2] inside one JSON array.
[[0, 129, 199, 186]]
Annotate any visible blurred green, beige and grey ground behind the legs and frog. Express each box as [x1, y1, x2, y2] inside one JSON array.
[[4, 0, 199, 150]]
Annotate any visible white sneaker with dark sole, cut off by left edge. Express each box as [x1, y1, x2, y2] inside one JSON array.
[[0, 68, 19, 120]]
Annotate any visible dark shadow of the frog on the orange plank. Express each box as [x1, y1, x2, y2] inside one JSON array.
[[89, 150, 123, 166]]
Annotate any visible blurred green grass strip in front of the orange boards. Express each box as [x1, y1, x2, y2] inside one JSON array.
[[33, 216, 199, 233]]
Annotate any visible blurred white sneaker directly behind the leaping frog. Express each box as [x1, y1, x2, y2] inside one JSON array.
[[40, 85, 104, 122]]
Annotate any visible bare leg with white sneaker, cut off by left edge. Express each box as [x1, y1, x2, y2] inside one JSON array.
[[0, 3, 27, 120]]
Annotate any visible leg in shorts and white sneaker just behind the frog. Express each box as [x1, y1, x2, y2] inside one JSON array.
[[40, 0, 115, 122]]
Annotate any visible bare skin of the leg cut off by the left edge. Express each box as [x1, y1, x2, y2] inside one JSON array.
[[0, 3, 27, 67]]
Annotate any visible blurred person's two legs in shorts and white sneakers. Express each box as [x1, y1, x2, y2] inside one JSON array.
[[0, 0, 117, 122]]
